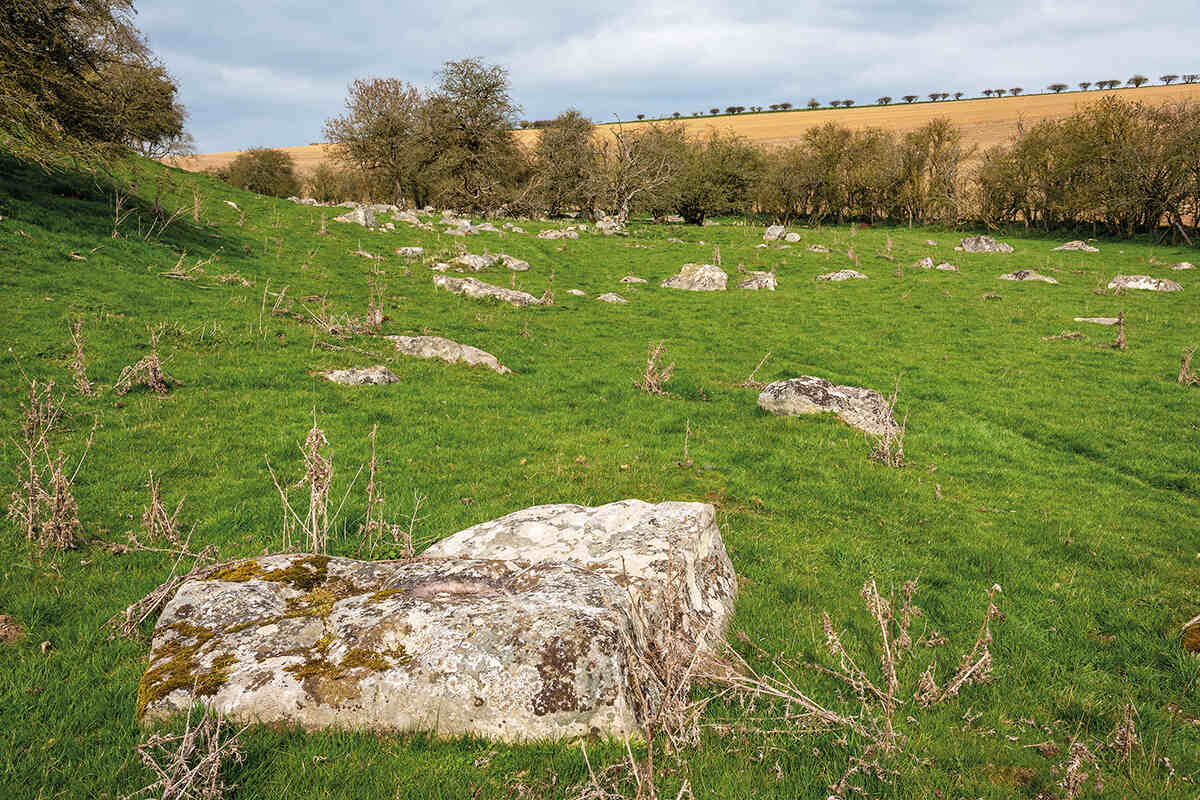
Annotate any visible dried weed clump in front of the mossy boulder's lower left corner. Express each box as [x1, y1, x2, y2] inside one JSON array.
[[127, 706, 250, 800]]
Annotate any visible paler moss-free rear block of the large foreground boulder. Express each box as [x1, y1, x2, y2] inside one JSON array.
[[421, 500, 737, 651]]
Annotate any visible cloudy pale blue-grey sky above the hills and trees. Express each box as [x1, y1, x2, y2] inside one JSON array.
[[137, 0, 1200, 152]]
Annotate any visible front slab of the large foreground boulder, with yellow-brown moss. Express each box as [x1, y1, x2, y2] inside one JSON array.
[[138, 555, 659, 741]]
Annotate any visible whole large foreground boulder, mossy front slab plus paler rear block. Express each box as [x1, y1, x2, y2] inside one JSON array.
[[138, 500, 737, 741]]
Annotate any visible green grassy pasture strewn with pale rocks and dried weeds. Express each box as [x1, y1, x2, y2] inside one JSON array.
[[0, 151, 1200, 800]]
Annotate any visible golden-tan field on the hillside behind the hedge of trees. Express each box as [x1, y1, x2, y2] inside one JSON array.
[[171, 84, 1200, 173]]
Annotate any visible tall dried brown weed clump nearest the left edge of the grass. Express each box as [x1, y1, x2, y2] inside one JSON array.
[[8, 379, 95, 552]]
